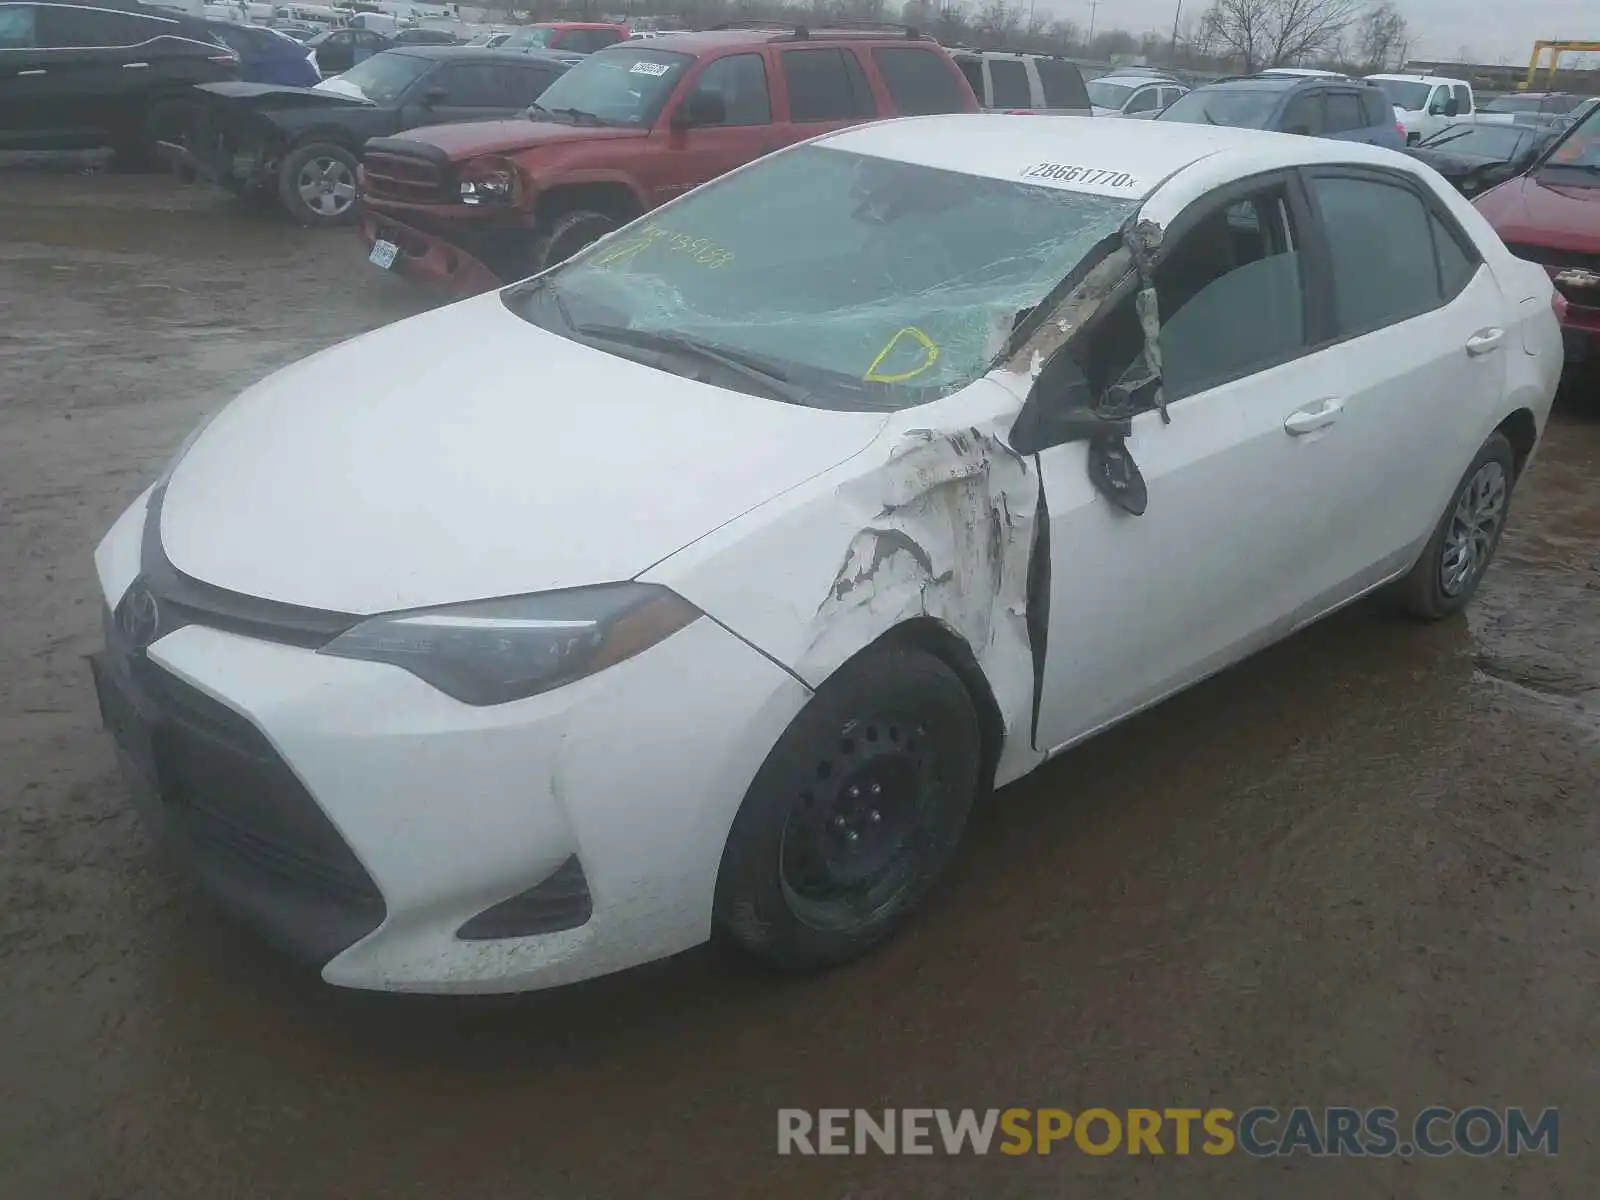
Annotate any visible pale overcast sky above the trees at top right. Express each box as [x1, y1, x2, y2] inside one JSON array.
[[1049, 0, 1600, 62]]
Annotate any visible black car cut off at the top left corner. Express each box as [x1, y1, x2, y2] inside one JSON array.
[[0, 0, 238, 165]]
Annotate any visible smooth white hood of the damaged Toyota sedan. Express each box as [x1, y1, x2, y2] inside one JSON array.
[[160, 293, 888, 614]]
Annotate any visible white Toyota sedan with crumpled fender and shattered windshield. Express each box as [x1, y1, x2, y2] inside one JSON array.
[[94, 115, 1562, 992]]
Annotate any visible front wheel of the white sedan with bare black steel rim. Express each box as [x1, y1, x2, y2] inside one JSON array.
[[714, 650, 984, 971]]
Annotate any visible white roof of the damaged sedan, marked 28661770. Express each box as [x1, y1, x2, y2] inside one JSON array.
[[816, 112, 1413, 200]]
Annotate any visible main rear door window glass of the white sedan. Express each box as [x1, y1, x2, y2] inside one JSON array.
[[1310, 176, 1440, 336]]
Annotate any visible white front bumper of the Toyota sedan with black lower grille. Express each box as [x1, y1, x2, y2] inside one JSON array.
[[94, 505, 810, 992]]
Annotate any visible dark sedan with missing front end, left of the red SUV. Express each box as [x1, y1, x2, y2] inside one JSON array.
[[166, 46, 570, 226]]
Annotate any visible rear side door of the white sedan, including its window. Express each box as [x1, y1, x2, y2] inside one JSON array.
[[1304, 168, 1520, 604]]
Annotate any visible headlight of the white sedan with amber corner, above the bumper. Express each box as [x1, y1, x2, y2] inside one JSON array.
[[317, 584, 701, 706]]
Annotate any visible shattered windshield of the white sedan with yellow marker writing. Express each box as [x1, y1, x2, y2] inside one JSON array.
[[504, 142, 1138, 410]]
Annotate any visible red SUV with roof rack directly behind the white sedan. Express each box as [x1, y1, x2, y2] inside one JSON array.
[[360, 26, 979, 294]]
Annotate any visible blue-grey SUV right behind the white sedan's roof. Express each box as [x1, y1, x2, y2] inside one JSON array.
[[1157, 75, 1405, 150]]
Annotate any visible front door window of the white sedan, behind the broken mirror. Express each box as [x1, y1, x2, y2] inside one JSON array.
[[1085, 187, 1306, 410]]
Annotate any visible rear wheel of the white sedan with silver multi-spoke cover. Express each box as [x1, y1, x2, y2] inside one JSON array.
[[1400, 434, 1517, 621]]
